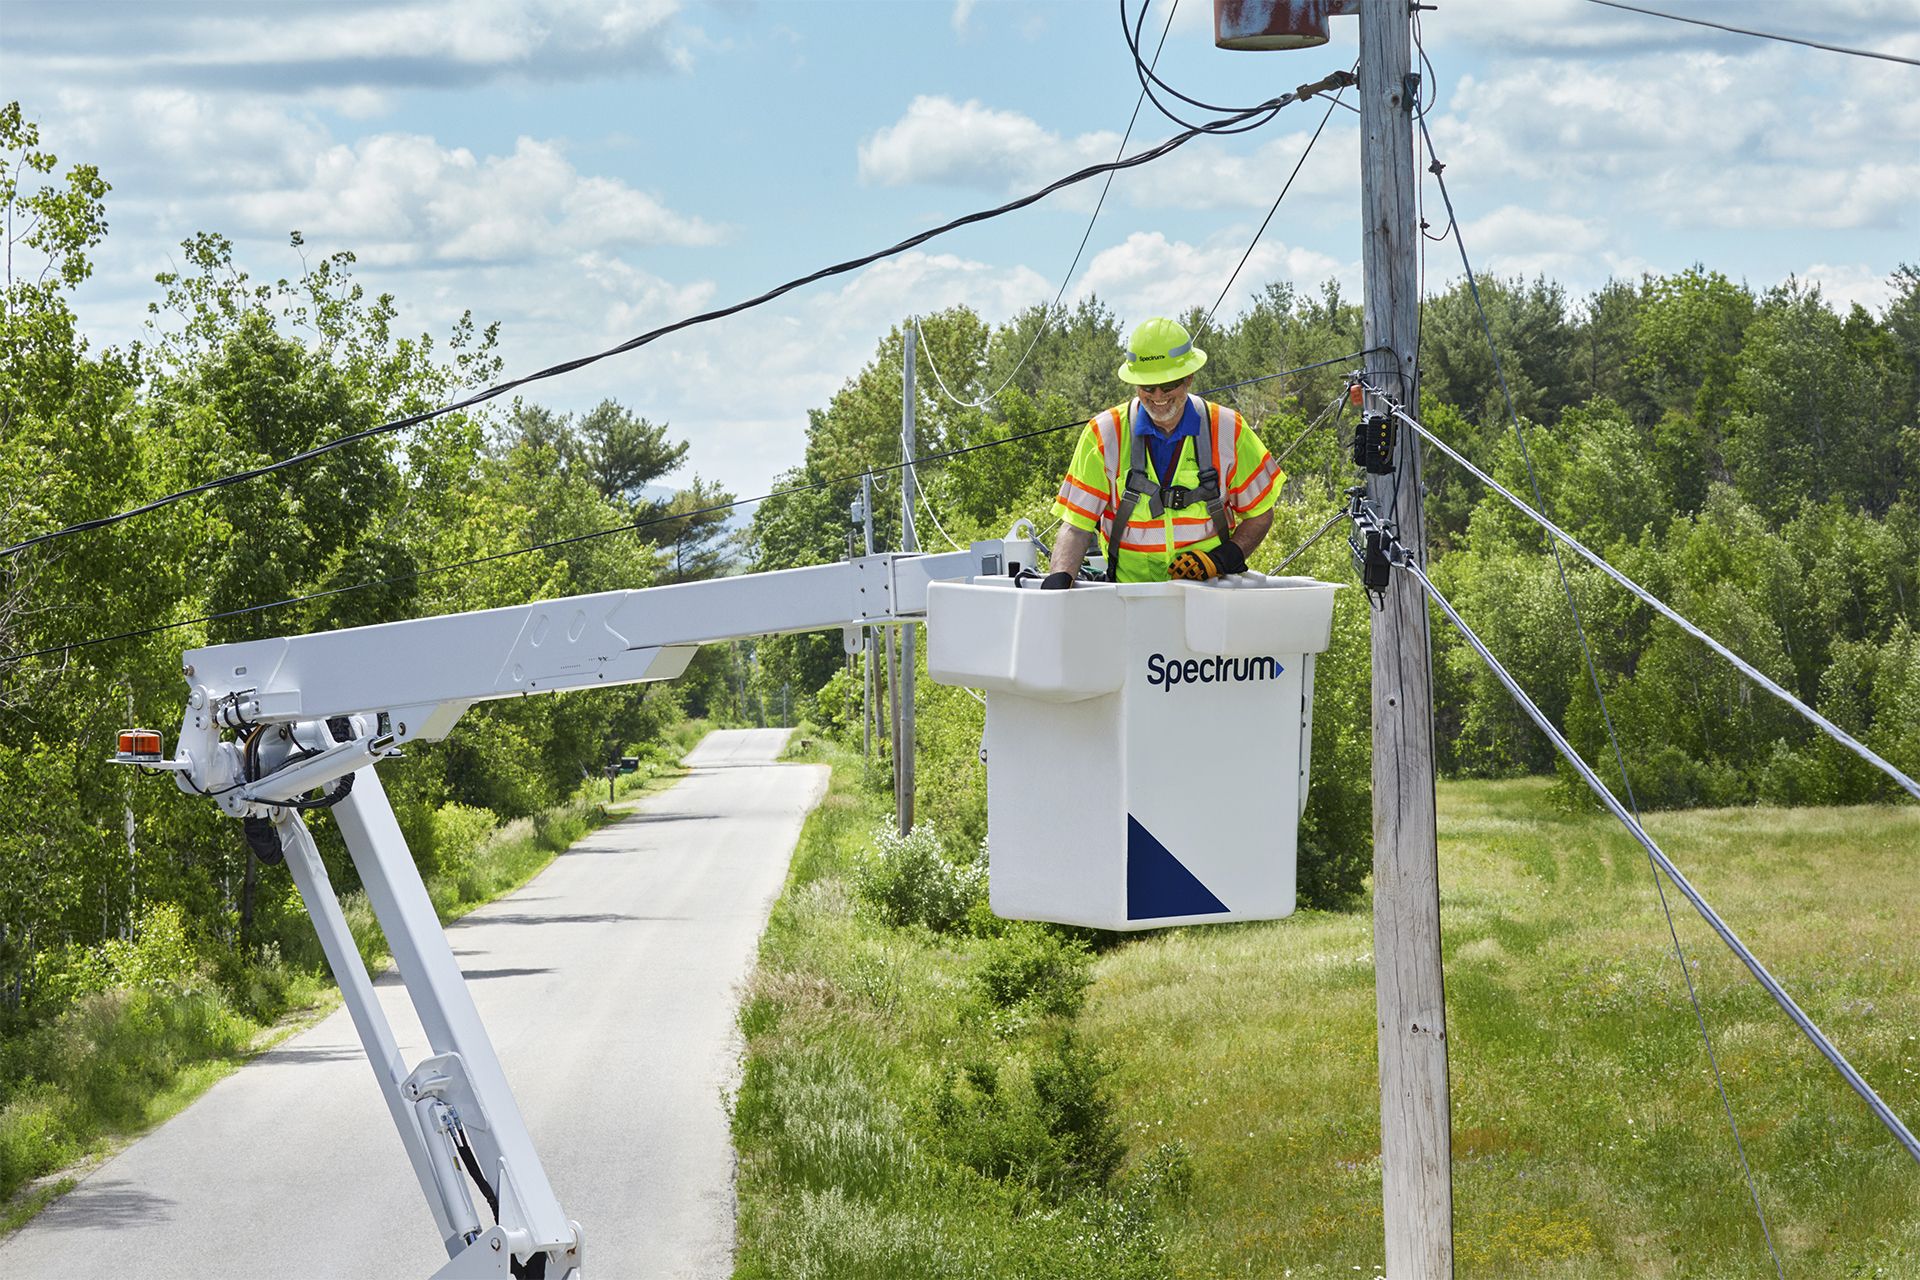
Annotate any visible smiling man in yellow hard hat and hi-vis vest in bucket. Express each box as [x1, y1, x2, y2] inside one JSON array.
[[1041, 317, 1286, 589]]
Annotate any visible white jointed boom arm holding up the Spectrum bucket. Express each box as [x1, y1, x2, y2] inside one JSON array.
[[144, 539, 1033, 1280]]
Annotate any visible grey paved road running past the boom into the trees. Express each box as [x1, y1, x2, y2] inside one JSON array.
[[0, 729, 826, 1280]]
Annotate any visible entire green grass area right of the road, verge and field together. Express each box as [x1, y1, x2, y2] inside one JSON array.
[[735, 756, 1920, 1278]]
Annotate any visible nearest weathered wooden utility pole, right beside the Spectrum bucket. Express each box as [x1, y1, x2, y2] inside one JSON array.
[[1359, 0, 1453, 1280]]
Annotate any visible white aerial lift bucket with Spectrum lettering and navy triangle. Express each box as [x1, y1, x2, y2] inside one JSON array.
[[927, 574, 1336, 929]]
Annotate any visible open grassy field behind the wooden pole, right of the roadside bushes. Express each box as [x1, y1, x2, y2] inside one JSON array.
[[1085, 781, 1920, 1278]]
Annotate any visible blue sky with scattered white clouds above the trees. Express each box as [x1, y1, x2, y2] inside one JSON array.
[[0, 0, 1920, 493]]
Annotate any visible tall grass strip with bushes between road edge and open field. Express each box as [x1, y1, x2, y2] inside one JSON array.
[[733, 745, 1187, 1280]]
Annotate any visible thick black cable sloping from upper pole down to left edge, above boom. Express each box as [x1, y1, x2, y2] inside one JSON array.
[[0, 92, 1320, 557]]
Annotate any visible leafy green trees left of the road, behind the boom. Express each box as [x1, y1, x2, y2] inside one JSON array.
[[0, 104, 745, 1028]]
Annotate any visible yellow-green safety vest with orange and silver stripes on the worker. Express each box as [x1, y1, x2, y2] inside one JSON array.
[[1054, 397, 1284, 581]]
